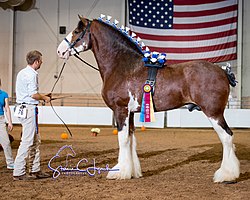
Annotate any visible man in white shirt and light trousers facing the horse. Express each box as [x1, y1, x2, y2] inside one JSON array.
[[13, 50, 50, 180]]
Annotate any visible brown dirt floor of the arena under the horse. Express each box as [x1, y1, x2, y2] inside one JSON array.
[[0, 126, 250, 200]]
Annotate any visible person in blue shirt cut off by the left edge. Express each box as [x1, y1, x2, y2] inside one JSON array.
[[0, 79, 14, 169]]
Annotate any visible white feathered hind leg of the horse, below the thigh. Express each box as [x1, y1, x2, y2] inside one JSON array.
[[209, 116, 240, 182]]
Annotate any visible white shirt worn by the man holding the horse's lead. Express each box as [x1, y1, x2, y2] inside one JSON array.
[[16, 65, 39, 104]]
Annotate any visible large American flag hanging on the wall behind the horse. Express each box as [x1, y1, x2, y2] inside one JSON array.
[[128, 0, 238, 63]]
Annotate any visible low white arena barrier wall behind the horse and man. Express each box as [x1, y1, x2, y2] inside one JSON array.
[[11, 106, 250, 128]]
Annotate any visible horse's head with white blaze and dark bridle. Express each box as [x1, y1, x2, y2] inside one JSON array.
[[57, 16, 91, 58]]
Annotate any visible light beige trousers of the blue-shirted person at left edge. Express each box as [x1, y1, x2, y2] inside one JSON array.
[[0, 115, 14, 166]]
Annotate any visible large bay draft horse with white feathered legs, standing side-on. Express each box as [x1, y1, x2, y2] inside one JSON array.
[[57, 16, 240, 182]]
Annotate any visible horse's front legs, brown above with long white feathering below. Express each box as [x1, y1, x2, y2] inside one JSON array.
[[107, 109, 141, 179]]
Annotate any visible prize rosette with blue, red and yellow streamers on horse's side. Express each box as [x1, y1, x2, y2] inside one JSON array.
[[140, 84, 155, 122]]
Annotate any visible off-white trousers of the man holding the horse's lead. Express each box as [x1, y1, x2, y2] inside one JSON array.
[[13, 105, 41, 176]]
